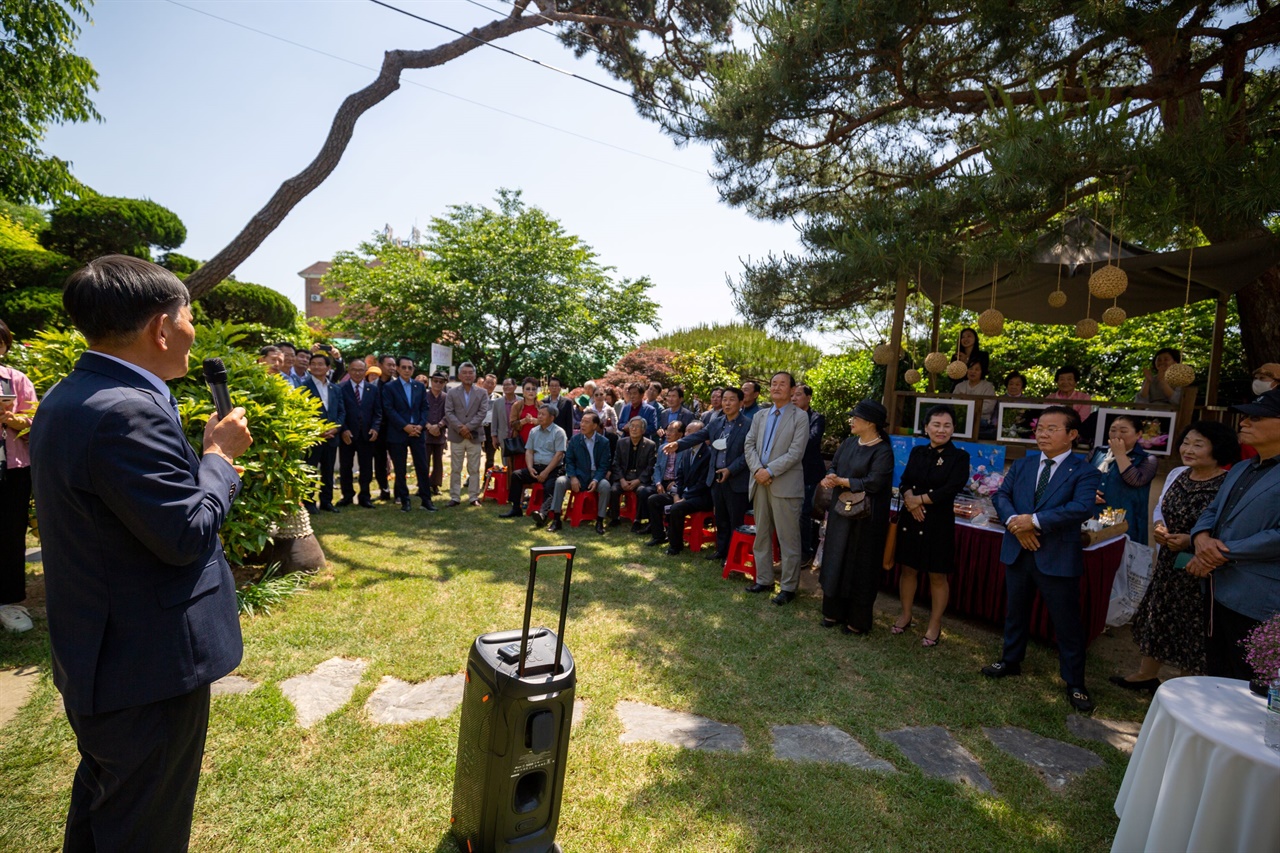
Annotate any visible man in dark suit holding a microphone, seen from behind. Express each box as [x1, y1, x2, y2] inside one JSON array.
[[31, 255, 252, 850]]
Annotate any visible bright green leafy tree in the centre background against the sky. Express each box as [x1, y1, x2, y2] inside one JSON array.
[[325, 190, 658, 383]]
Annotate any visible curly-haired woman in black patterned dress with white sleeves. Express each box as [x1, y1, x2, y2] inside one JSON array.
[[1111, 420, 1240, 690]]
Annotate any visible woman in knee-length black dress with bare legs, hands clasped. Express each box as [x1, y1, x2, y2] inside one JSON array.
[[893, 406, 969, 648]]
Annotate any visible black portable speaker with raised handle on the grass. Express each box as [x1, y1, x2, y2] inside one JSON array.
[[449, 546, 577, 853]]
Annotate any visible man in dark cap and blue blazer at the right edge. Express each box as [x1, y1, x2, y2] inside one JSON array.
[[1187, 388, 1280, 680]]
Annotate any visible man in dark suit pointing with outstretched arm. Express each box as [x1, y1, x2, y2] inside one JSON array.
[[666, 388, 751, 562]]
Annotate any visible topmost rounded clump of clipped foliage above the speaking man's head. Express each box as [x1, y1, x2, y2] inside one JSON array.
[[40, 195, 187, 261]]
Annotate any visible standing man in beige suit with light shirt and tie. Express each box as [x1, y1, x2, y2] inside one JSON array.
[[744, 373, 809, 606]]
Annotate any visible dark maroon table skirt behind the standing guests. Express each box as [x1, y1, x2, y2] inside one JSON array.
[[881, 524, 1126, 643]]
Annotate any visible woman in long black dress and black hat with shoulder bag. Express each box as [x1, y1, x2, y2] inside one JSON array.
[[818, 400, 893, 634]]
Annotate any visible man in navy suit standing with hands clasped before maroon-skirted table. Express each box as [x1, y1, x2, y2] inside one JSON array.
[[982, 406, 1102, 712]]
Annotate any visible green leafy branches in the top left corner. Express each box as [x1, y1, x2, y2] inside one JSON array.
[[0, 0, 101, 201]]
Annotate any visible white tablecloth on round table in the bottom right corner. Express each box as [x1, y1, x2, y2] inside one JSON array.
[[1111, 678, 1280, 853]]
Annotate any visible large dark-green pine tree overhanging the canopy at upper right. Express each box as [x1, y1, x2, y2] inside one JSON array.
[[663, 0, 1280, 364]]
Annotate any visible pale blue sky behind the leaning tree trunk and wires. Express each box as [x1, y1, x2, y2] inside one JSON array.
[[45, 0, 796, 343]]
